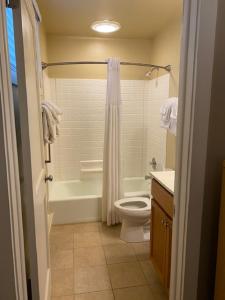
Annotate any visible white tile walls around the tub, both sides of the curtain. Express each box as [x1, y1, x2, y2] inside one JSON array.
[[47, 76, 169, 180]]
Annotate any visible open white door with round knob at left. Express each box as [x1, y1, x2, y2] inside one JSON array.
[[14, 0, 50, 300]]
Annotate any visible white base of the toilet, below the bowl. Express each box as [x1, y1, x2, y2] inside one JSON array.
[[120, 220, 150, 243]]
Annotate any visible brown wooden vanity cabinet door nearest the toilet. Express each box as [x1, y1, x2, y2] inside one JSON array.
[[151, 199, 167, 282]]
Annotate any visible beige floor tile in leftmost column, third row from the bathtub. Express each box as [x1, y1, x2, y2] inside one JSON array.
[[51, 250, 73, 269]]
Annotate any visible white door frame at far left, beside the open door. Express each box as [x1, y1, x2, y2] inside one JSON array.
[[0, 0, 27, 300]]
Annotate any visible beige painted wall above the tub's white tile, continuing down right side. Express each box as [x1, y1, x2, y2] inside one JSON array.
[[40, 20, 181, 169]]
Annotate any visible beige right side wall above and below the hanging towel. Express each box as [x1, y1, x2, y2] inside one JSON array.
[[151, 20, 181, 169]]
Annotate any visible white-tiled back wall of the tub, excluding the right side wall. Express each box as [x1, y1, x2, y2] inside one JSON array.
[[51, 79, 144, 180]]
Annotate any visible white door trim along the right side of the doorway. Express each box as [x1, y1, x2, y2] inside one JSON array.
[[170, 0, 218, 300]]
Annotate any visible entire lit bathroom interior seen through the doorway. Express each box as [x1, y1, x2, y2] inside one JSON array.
[[3, 0, 182, 300]]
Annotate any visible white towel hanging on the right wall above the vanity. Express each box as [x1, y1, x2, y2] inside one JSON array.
[[160, 97, 178, 135]]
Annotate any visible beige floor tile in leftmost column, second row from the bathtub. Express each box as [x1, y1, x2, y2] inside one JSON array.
[[50, 232, 73, 251]]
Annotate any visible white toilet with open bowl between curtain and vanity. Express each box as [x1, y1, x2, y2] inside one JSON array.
[[114, 197, 151, 242]]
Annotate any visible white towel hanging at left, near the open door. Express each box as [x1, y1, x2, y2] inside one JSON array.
[[41, 101, 62, 144]]
